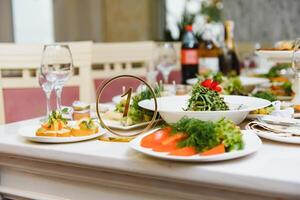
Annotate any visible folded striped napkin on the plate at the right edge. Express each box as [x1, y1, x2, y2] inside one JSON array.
[[246, 121, 300, 137]]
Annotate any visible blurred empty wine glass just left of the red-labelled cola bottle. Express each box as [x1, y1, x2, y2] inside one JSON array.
[[156, 43, 177, 83]]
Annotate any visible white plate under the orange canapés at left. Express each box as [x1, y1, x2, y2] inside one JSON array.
[[18, 125, 107, 143]]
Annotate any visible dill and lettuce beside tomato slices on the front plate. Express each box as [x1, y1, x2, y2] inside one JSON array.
[[171, 118, 244, 152]]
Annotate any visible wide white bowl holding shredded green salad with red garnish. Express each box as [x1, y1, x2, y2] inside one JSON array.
[[139, 79, 271, 124]]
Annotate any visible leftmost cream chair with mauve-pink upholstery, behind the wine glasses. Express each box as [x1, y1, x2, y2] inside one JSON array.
[[0, 42, 92, 123]]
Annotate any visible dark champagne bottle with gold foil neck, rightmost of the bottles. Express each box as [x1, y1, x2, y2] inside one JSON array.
[[219, 21, 240, 75]]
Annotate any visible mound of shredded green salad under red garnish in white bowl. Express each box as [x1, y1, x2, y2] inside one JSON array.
[[187, 84, 229, 111]]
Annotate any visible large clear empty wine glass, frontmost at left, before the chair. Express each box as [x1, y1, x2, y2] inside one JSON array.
[[41, 44, 73, 110]]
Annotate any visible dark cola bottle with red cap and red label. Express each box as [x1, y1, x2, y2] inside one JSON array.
[[181, 25, 199, 84]]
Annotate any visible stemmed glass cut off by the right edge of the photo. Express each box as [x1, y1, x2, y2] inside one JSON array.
[[292, 38, 300, 105]]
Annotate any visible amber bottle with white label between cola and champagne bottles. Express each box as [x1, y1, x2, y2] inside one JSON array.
[[198, 29, 220, 72]]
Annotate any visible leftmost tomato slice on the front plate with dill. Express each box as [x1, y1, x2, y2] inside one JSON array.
[[141, 128, 171, 148]]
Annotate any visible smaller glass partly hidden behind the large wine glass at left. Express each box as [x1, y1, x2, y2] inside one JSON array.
[[38, 73, 54, 121]]
